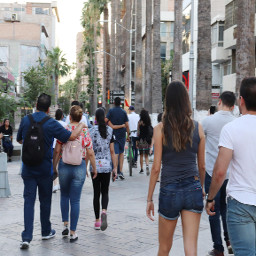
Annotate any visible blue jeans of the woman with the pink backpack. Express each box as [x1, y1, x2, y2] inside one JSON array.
[[59, 159, 86, 231]]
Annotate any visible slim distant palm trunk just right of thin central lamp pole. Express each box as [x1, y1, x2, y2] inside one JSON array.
[[135, 0, 142, 113]]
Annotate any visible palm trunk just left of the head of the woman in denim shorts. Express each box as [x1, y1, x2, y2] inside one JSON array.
[[152, 0, 163, 113]]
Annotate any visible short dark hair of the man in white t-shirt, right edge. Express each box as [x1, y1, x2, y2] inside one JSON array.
[[240, 77, 256, 111]]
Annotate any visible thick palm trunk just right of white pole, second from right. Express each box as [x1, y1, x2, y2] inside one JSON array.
[[196, 0, 212, 110]]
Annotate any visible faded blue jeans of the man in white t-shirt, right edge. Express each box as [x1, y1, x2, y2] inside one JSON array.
[[227, 197, 256, 256]]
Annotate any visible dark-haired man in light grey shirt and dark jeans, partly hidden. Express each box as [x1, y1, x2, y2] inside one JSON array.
[[202, 91, 236, 256]]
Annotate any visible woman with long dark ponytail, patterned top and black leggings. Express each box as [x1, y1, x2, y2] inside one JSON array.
[[90, 108, 117, 231]]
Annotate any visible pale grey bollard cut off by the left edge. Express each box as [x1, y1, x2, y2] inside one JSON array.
[[0, 153, 11, 197]]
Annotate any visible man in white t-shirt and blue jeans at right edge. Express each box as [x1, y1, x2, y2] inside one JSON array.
[[206, 77, 256, 256]]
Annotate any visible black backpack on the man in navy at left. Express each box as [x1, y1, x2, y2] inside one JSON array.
[[22, 115, 50, 166]]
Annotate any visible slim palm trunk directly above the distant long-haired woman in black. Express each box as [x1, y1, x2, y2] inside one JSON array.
[[144, 0, 152, 113]]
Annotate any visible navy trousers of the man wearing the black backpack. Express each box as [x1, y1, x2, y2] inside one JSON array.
[[21, 176, 52, 242]]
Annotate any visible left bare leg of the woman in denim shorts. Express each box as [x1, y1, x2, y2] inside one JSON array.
[[158, 216, 178, 256]]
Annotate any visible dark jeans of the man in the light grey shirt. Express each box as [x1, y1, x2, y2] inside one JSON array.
[[205, 172, 229, 252]]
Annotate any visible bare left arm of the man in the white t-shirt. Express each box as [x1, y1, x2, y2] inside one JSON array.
[[205, 147, 233, 216]]
